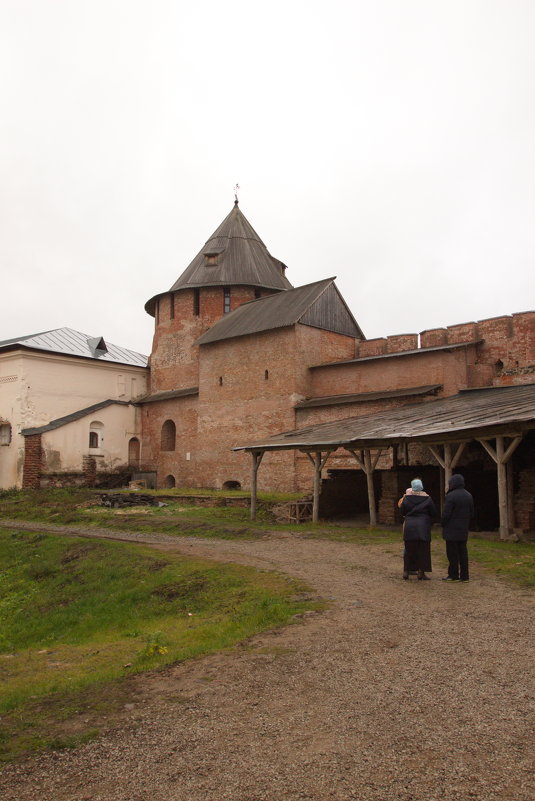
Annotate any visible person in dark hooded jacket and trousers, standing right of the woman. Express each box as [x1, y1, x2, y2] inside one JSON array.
[[442, 474, 474, 581]]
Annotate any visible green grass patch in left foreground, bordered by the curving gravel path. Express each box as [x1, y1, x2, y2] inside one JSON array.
[[0, 529, 313, 759]]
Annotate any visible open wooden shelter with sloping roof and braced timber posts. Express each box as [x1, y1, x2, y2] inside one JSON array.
[[234, 384, 535, 538]]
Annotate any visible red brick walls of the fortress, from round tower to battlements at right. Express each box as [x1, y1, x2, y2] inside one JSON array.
[[141, 296, 535, 492]]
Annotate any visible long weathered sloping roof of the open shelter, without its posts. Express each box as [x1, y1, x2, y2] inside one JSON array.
[[237, 384, 535, 450]]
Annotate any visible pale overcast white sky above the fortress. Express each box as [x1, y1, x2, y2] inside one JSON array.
[[0, 0, 535, 353]]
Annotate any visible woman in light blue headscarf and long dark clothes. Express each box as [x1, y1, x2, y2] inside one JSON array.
[[398, 478, 437, 581]]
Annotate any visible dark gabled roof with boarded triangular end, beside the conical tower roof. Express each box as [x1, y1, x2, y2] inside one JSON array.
[[196, 278, 364, 345]]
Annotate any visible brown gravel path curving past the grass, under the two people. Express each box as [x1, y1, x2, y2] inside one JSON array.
[[0, 523, 535, 801]]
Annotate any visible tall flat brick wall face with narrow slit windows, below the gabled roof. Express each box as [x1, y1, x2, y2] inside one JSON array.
[[196, 328, 300, 490]]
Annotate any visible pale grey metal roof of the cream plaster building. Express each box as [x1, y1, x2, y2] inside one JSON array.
[[0, 328, 148, 367]]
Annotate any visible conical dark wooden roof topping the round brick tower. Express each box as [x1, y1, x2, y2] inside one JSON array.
[[145, 205, 292, 316]]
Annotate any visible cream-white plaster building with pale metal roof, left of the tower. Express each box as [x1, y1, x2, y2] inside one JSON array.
[[0, 328, 148, 488]]
